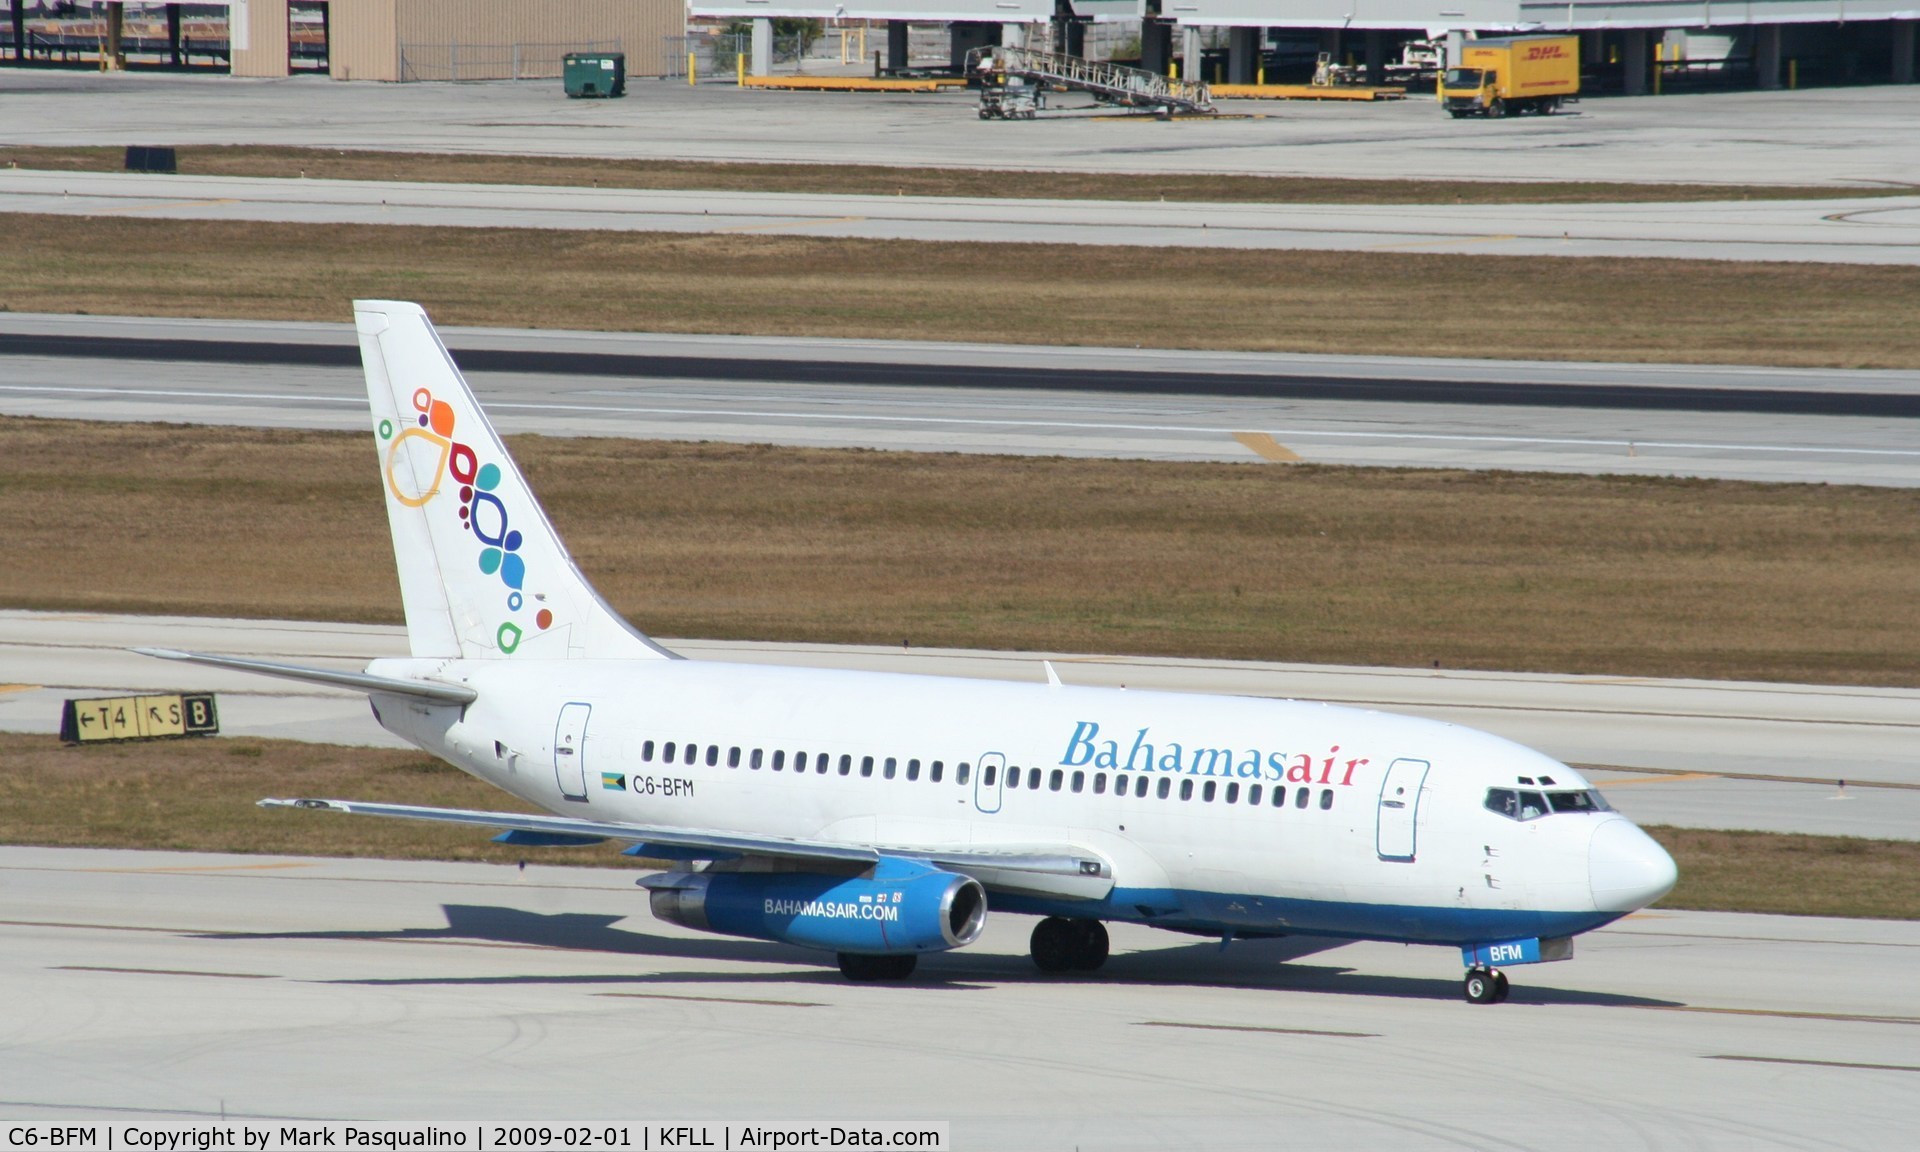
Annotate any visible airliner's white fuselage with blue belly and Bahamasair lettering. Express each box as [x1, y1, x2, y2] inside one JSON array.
[[369, 660, 1670, 945]]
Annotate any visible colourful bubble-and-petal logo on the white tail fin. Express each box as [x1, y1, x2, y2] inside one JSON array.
[[378, 388, 553, 653]]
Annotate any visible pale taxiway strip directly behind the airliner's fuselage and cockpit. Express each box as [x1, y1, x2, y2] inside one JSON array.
[[0, 611, 1920, 839]]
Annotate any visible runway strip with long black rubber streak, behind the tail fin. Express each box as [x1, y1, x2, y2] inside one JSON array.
[[0, 313, 1920, 486]]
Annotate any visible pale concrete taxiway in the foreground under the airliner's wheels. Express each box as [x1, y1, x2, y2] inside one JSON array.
[[0, 840, 1920, 1152]]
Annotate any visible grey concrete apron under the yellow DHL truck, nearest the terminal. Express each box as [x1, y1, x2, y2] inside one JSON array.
[[0, 69, 1920, 186]]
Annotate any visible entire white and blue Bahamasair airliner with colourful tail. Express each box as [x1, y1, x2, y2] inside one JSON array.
[[142, 301, 1674, 1004]]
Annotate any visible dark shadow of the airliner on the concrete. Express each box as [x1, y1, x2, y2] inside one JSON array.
[[204, 904, 1676, 1006]]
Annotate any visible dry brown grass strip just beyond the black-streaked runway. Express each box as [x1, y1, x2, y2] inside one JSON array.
[[0, 215, 1920, 369]]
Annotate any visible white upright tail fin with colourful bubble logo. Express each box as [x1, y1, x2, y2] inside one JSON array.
[[353, 300, 674, 659]]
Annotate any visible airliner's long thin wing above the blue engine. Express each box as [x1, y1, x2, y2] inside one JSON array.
[[259, 799, 1114, 900]]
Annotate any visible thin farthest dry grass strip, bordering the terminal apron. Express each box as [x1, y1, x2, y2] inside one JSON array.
[[0, 144, 1910, 204]]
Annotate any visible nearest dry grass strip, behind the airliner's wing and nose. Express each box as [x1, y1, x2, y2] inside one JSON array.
[[0, 733, 1920, 920]]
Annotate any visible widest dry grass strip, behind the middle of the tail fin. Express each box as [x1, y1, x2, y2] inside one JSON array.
[[11, 419, 1920, 685]]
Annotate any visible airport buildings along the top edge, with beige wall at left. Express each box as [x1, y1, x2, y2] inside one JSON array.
[[0, 0, 1920, 94]]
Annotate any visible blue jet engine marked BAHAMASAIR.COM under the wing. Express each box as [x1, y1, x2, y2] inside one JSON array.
[[639, 858, 987, 956]]
